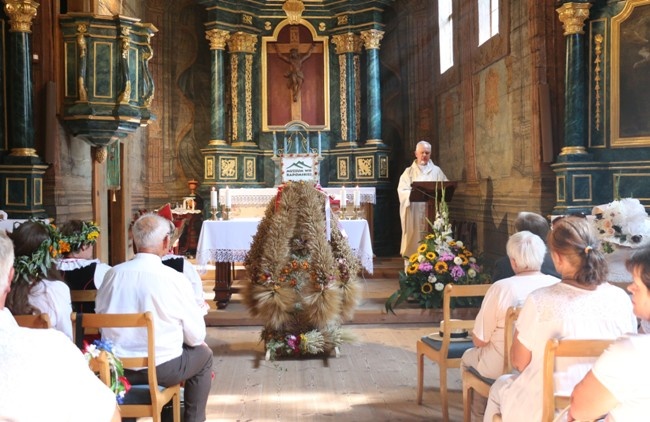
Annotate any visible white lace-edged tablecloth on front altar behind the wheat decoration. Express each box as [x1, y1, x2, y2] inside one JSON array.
[[196, 218, 373, 274]]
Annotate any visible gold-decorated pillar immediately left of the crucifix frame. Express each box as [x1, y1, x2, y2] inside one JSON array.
[[227, 32, 257, 147]]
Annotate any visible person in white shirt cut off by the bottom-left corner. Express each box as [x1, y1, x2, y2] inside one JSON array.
[[0, 230, 120, 422]]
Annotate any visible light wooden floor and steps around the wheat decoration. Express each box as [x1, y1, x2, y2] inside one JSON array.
[[140, 260, 462, 422]]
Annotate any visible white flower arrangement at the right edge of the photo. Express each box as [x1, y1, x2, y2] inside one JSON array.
[[591, 198, 650, 253]]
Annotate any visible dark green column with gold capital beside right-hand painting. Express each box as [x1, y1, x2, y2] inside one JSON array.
[[557, 2, 591, 156]]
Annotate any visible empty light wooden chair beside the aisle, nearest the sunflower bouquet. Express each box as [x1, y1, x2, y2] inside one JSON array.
[[416, 284, 490, 421]]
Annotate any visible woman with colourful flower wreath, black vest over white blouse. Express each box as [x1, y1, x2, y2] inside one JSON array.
[[57, 220, 111, 312]]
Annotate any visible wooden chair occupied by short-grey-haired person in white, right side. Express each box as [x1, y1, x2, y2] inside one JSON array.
[[461, 306, 521, 422]]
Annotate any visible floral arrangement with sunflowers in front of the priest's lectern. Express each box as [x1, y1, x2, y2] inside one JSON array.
[[385, 193, 490, 313]]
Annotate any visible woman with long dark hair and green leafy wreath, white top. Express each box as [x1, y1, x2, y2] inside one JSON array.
[[6, 220, 72, 340]]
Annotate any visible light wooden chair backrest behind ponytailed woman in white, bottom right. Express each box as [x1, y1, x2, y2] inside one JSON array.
[[542, 339, 614, 422]]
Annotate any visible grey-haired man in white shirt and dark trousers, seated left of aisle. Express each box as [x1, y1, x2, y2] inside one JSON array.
[[96, 214, 212, 422]]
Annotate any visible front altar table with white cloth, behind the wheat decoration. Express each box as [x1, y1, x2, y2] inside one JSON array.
[[196, 218, 373, 308]]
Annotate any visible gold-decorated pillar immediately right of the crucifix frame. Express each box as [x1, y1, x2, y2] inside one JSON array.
[[332, 32, 362, 147]]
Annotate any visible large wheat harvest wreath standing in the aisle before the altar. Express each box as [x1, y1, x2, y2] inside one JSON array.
[[243, 182, 361, 358]]
